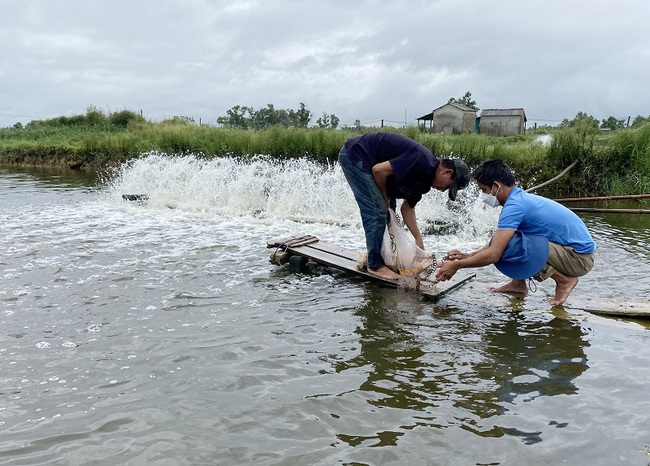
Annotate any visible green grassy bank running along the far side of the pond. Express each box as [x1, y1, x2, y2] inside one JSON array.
[[0, 109, 650, 196]]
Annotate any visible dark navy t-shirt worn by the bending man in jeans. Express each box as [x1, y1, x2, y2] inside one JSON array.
[[345, 133, 440, 207]]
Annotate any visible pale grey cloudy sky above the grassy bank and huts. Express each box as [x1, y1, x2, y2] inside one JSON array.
[[0, 0, 650, 127]]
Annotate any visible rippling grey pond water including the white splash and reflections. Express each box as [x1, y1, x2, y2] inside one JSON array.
[[0, 154, 650, 465]]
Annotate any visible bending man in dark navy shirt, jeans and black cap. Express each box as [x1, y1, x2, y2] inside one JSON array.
[[339, 133, 469, 280]]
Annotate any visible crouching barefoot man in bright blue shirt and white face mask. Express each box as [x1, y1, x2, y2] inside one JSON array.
[[436, 159, 596, 306]]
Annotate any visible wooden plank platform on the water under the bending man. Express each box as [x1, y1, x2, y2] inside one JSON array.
[[267, 236, 476, 300]]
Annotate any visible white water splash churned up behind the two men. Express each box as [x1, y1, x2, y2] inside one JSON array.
[[101, 152, 497, 248]]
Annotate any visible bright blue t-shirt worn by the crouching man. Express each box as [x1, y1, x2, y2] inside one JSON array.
[[497, 187, 596, 254]]
